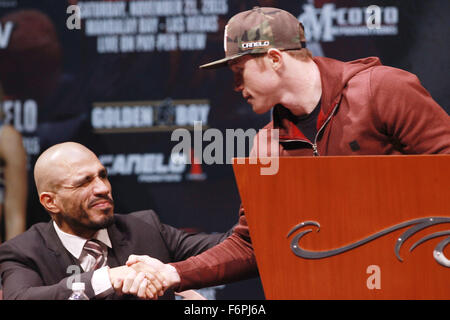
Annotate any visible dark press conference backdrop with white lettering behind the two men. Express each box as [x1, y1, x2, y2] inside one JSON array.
[[0, 0, 450, 299]]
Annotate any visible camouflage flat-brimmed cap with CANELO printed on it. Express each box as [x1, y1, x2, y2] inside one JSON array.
[[200, 7, 306, 69]]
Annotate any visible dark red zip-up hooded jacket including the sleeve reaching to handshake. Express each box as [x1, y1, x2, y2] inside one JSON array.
[[173, 57, 450, 290]]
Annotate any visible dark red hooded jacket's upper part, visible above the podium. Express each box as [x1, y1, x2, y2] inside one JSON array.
[[252, 57, 450, 156]]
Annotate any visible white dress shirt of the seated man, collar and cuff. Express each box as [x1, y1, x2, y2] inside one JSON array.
[[53, 221, 113, 296]]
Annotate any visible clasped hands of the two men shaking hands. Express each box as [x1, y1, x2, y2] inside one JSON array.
[[108, 255, 202, 300]]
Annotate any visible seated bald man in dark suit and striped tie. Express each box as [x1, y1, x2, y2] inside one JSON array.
[[0, 142, 227, 299]]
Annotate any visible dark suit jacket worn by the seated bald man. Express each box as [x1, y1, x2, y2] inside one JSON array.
[[0, 210, 230, 300]]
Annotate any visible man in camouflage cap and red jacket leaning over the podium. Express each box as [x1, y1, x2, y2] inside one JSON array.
[[126, 7, 450, 291]]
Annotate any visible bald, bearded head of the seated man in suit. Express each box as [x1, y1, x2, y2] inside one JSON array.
[[34, 142, 114, 235]]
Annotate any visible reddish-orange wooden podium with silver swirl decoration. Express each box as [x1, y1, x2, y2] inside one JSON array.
[[233, 155, 450, 299]]
